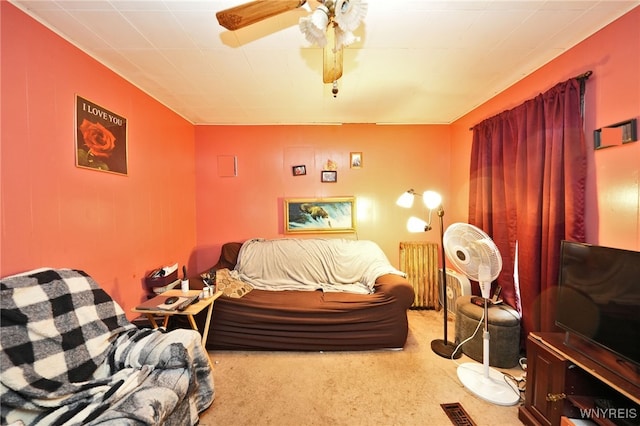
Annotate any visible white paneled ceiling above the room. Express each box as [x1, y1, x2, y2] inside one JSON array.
[[10, 0, 640, 124]]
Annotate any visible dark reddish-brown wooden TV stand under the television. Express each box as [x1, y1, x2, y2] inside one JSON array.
[[518, 332, 640, 426]]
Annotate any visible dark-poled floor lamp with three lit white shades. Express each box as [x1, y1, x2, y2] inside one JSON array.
[[396, 189, 462, 359]]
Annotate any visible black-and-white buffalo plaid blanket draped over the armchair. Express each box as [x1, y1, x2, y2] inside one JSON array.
[[0, 269, 214, 425]]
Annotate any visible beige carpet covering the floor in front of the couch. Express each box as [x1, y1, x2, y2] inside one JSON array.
[[200, 311, 522, 426]]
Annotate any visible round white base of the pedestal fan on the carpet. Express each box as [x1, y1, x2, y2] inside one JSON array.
[[458, 362, 520, 406]]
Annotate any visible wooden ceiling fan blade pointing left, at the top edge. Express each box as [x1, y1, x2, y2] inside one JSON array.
[[216, 0, 306, 31]]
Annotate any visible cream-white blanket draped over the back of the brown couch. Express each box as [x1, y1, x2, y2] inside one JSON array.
[[235, 238, 405, 294]]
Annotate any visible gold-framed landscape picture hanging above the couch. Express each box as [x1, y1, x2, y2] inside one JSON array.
[[284, 197, 356, 234]]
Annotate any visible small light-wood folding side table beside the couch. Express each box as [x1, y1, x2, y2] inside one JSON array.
[[131, 290, 222, 351]]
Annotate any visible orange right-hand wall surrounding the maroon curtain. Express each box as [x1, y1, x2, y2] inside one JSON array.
[[451, 7, 640, 250]]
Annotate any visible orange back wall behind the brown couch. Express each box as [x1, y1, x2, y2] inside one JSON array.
[[196, 124, 450, 270]]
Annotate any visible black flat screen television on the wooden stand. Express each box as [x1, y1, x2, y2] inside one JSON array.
[[556, 241, 640, 377]]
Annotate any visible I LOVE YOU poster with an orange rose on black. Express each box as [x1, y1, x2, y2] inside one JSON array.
[[75, 95, 127, 176]]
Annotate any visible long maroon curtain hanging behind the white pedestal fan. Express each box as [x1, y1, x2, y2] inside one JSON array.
[[469, 79, 587, 336]]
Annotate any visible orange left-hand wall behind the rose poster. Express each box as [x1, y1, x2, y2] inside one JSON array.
[[0, 1, 196, 311]]
